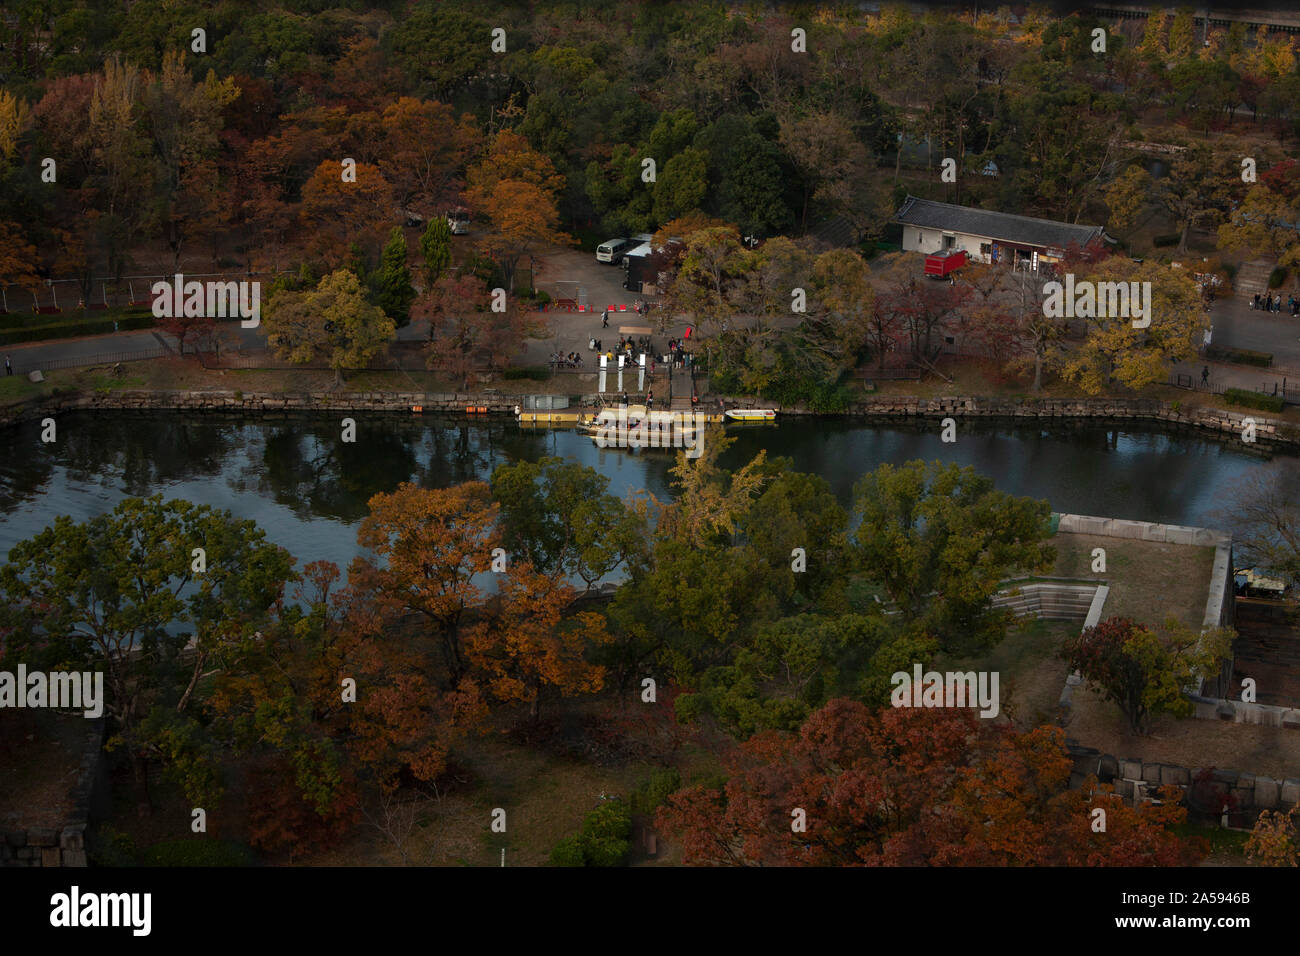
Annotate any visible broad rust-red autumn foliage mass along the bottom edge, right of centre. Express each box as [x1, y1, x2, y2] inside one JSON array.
[[657, 700, 1197, 866]]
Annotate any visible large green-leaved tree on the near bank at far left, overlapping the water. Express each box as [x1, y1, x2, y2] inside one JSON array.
[[0, 494, 294, 808]]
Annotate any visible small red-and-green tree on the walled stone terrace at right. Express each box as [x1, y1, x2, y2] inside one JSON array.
[[1061, 618, 1234, 734]]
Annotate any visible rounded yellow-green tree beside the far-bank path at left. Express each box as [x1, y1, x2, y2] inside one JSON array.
[[261, 269, 397, 385]]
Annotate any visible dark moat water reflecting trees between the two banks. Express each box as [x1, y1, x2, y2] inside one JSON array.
[[0, 412, 1300, 566]]
